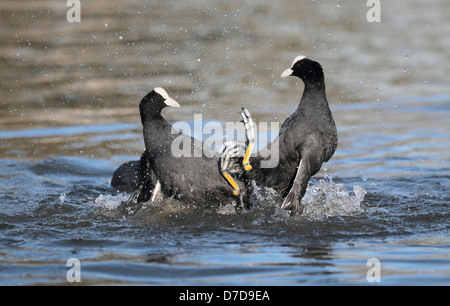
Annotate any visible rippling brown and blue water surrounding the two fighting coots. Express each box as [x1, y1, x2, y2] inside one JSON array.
[[0, 0, 450, 285]]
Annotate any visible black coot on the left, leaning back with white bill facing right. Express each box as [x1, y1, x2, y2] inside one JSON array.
[[125, 87, 245, 204]]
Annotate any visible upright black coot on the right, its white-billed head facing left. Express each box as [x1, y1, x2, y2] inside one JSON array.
[[239, 56, 338, 214]]
